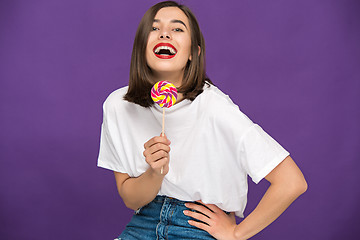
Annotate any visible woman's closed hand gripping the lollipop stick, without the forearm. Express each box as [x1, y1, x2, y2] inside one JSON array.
[[143, 135, 171, 175]]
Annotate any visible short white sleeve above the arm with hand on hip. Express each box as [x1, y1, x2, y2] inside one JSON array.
[[240, 124, 289, 184]]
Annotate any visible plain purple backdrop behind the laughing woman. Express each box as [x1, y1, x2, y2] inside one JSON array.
[[0, 0, 360, 240]]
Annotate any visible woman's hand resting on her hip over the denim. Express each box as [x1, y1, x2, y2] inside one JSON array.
[[184, 201, 236, 240]]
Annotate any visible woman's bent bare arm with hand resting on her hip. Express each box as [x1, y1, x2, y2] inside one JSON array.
[[185, 156, 307, 240]]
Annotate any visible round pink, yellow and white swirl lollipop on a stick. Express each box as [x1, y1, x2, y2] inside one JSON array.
[[151, 81, 177, 174]]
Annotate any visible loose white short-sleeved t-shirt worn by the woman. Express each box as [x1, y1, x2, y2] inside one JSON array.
[[98, 84, 289, 217]]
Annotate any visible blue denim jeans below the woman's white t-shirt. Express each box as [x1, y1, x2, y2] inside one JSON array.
[[115, 196, 215, 240]]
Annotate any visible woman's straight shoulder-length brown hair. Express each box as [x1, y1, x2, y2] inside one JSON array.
[[124, 1, 212, 107]]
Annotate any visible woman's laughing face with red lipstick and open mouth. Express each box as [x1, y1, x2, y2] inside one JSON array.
[[146, 7, 191, 83]]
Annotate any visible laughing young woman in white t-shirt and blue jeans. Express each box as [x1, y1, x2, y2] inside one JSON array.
[[98, 1, 307, 240]]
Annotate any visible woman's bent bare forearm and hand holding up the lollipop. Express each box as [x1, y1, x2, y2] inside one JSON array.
[[114, 136, 170, 210]]
